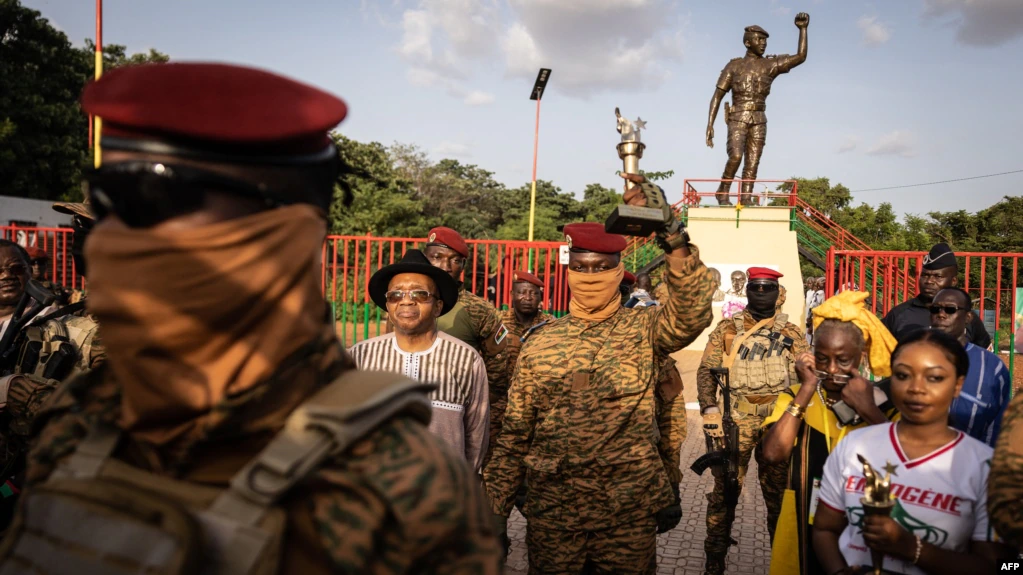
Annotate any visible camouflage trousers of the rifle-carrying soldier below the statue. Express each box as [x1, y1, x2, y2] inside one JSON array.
[[704, 415, 789, 558]]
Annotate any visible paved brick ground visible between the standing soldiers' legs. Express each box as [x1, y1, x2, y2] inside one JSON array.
[[505, 407, 770, 575]]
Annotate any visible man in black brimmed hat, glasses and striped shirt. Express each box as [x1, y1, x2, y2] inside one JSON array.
[[349, 250, 490, 472]]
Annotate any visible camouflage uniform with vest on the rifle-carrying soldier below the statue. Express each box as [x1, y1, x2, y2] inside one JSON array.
[[697, 288, 810, 573]]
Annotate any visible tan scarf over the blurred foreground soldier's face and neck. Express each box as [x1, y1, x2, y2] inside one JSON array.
[[86, 205, 326, 443]]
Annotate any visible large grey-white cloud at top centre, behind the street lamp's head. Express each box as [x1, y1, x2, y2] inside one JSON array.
[[502, 0, 684, 97]]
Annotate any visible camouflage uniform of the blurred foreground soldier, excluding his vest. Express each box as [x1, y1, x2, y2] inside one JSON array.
[[20, 330, 503, 575]]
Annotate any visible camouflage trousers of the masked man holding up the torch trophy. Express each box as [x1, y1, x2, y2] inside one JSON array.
[[526, 515, 657, 575]]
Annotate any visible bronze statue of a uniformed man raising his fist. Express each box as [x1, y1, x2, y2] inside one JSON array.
[[707, 12, 810, 206]]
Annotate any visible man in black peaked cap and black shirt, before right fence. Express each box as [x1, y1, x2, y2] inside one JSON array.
[[882, 244, 991, 349]]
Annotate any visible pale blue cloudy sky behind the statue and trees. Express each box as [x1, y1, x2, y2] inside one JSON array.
[[23, 0, 1023, 214]]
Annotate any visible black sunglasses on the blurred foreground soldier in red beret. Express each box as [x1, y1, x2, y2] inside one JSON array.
[[85, 162, 287, 227]]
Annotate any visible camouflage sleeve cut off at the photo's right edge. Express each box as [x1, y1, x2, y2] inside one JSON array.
[[987, 382, 1023, 548]]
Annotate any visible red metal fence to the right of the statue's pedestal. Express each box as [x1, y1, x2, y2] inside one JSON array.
[[826, 249, 1023, 349]]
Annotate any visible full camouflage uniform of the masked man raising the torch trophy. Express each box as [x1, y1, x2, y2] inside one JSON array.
[[484, 246, 712, 573]]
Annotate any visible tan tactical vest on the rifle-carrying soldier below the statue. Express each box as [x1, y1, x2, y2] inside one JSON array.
[[726, 313, 793, 401]]
